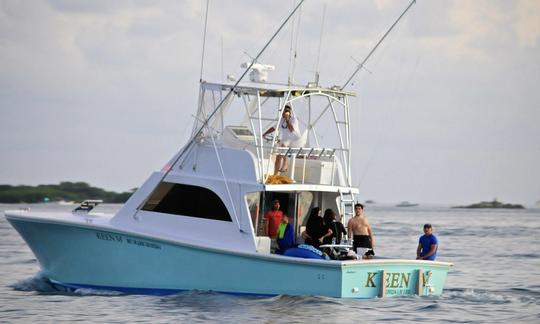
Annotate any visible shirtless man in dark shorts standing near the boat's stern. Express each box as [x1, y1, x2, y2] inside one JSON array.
[[347, 204, 375, 259]]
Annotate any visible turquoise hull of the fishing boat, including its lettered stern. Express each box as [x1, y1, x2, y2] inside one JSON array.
[[7, 215, 451, 298]]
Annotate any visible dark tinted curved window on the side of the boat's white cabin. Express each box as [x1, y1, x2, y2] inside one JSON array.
[[142, 182, 232, 222]]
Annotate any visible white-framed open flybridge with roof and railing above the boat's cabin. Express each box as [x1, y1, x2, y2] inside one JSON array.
[[192, 82, 355, 187]]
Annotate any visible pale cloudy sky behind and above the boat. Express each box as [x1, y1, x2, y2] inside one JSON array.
[[0, 0, 540, 206]]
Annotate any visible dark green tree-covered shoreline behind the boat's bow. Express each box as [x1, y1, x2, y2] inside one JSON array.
[[0, 182, 133, 204]]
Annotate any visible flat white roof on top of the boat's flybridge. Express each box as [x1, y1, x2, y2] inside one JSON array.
[[201, 81, 356, 97]]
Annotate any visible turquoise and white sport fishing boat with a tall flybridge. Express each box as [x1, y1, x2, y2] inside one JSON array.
[[5, 0, 451, 298]]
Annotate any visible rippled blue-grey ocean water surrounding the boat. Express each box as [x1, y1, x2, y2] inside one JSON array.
[[0, 205, 540, 323]]
